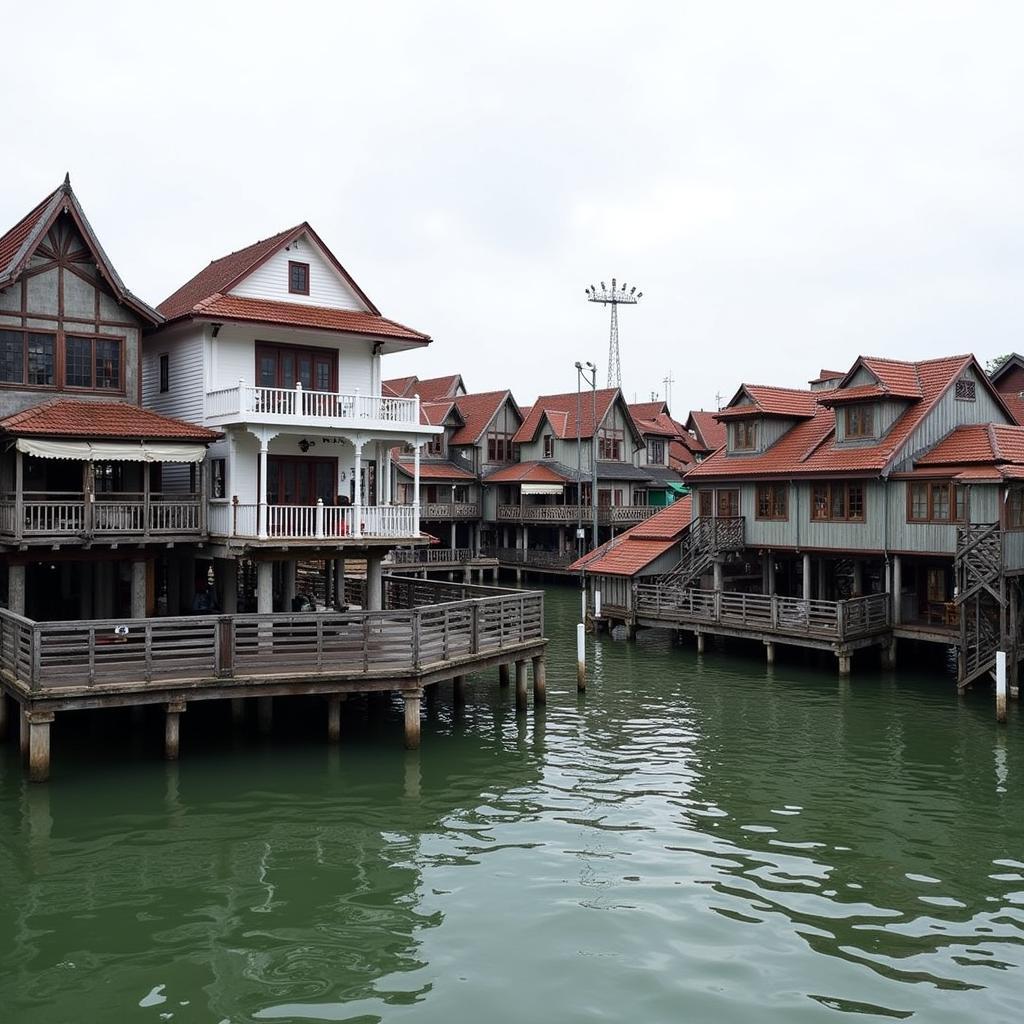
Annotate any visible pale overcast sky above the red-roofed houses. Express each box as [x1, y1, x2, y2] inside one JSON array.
[[0, 0, 1024, 415]]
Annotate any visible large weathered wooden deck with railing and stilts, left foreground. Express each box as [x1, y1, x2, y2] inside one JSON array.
[[0, 577, 547, 779]]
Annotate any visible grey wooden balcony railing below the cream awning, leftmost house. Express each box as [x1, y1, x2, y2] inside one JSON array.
[[0, 490, 205, 541]]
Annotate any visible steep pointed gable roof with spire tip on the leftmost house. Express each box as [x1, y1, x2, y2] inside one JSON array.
[[0, 176, 163, 326]]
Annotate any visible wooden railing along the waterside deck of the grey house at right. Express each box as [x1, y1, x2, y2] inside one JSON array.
[[635, 584, 892, 640]]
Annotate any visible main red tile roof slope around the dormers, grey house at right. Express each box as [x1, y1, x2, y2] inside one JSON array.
[[685, 355, 984, 482]]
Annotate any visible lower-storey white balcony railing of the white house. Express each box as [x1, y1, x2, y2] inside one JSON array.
[[208, 502, 420, 543]]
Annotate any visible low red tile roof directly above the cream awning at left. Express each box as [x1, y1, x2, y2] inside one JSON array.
[[0, 398, 223, 441]]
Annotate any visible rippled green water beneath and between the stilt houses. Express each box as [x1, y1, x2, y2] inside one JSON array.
[[0, 589, 1024, 1024]]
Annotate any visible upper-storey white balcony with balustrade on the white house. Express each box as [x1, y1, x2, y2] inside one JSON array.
[[206, 382, 435, 432]]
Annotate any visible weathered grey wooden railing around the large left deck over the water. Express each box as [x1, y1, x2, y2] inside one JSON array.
[[0, 581, 544, 693]]
